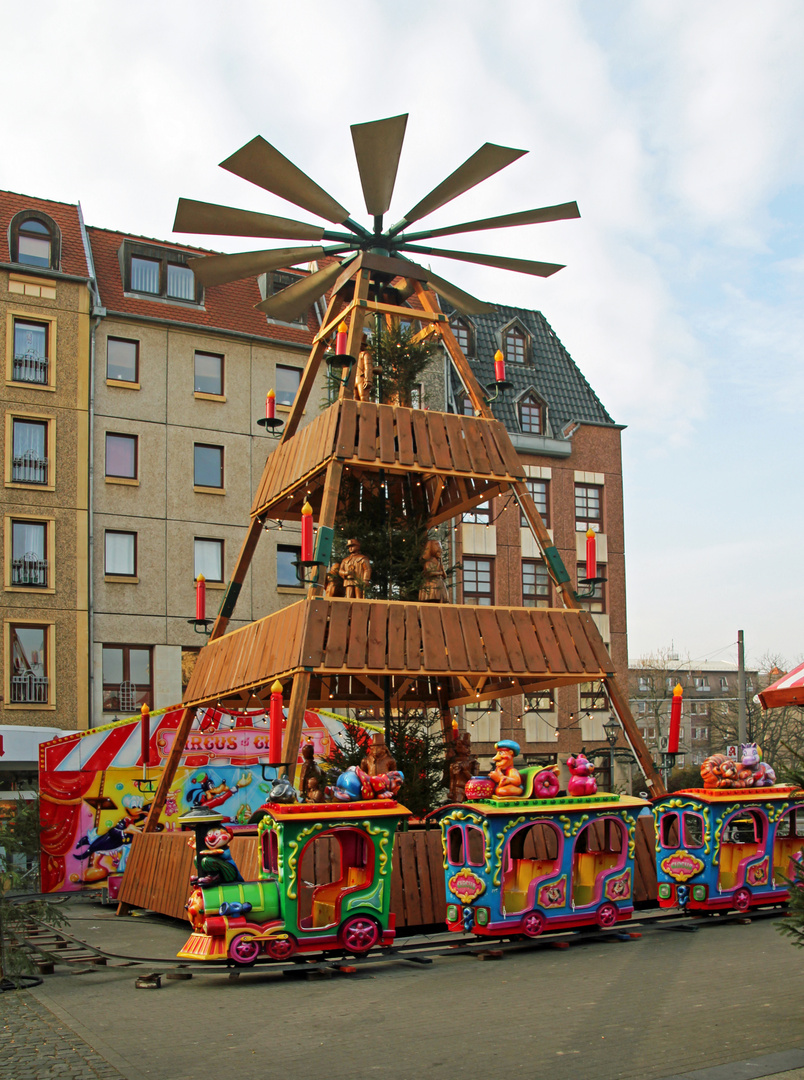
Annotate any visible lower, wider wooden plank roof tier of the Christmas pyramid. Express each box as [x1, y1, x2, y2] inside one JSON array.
[[184, 597, 613, 708]]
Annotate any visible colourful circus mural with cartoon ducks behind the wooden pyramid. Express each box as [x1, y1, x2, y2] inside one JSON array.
[[39, 708, 352, 897]]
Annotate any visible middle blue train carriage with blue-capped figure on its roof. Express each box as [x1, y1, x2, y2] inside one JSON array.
[[431, 740, 648, 937]]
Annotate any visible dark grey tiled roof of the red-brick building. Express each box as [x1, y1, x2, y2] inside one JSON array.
[[453, 305, 615, 437]]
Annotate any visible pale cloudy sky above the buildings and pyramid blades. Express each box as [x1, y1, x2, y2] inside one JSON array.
[[0, 0, 804, 663]]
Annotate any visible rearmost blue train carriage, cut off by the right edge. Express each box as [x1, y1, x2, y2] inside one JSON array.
[[653, 785, 804, 912]]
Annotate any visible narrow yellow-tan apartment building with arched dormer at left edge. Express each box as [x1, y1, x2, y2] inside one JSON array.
[[0, 191, 92, 729]]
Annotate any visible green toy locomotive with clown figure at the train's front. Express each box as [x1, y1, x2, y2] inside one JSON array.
[[177, 798, 410, 966]]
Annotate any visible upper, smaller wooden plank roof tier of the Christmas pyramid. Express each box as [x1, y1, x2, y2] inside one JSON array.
[[252, 399, 525, 527]]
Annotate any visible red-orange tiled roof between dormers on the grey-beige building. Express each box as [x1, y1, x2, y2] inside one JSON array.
[[86, 227, 323, 347]]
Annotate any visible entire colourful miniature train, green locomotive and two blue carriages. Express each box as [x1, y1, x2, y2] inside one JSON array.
[[172, 740, 804, 966]]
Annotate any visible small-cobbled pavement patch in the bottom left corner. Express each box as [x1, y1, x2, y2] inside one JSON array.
[[0, 990, 122, 1080]]
